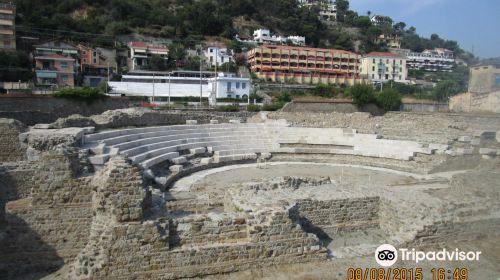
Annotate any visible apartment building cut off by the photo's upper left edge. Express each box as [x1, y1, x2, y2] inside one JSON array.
[[0, 3, 16, 49]]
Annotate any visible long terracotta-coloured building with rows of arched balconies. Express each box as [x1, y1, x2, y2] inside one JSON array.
[[248, 45, 361, 85]]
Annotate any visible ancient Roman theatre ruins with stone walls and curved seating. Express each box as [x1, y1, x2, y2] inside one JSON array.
[[0, 109, 500, 280]]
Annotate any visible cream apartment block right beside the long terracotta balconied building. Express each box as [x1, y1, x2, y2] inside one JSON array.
[[360, 52, 408, 83]]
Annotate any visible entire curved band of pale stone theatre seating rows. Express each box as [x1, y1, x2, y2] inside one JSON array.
[[83, 119, 449, 174]]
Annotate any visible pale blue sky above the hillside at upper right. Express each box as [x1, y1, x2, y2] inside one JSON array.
[[350, 0, 500, 58]]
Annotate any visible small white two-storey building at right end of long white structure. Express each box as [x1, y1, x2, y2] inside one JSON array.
[[208, 73, 251, 102]]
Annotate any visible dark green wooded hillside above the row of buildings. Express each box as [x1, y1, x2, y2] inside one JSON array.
[[16, 0, 471, 59]]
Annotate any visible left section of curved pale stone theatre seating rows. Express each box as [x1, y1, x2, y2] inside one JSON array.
[[83, 123, 286, 169]]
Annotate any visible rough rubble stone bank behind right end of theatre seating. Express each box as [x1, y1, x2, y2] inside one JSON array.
[[268, 112, 500, 144]]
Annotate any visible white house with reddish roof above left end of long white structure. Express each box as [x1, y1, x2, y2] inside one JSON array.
[[128, 42, 168, 70]]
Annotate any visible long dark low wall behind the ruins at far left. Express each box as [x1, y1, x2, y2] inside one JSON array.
[[0, 95, 130, 125]]
